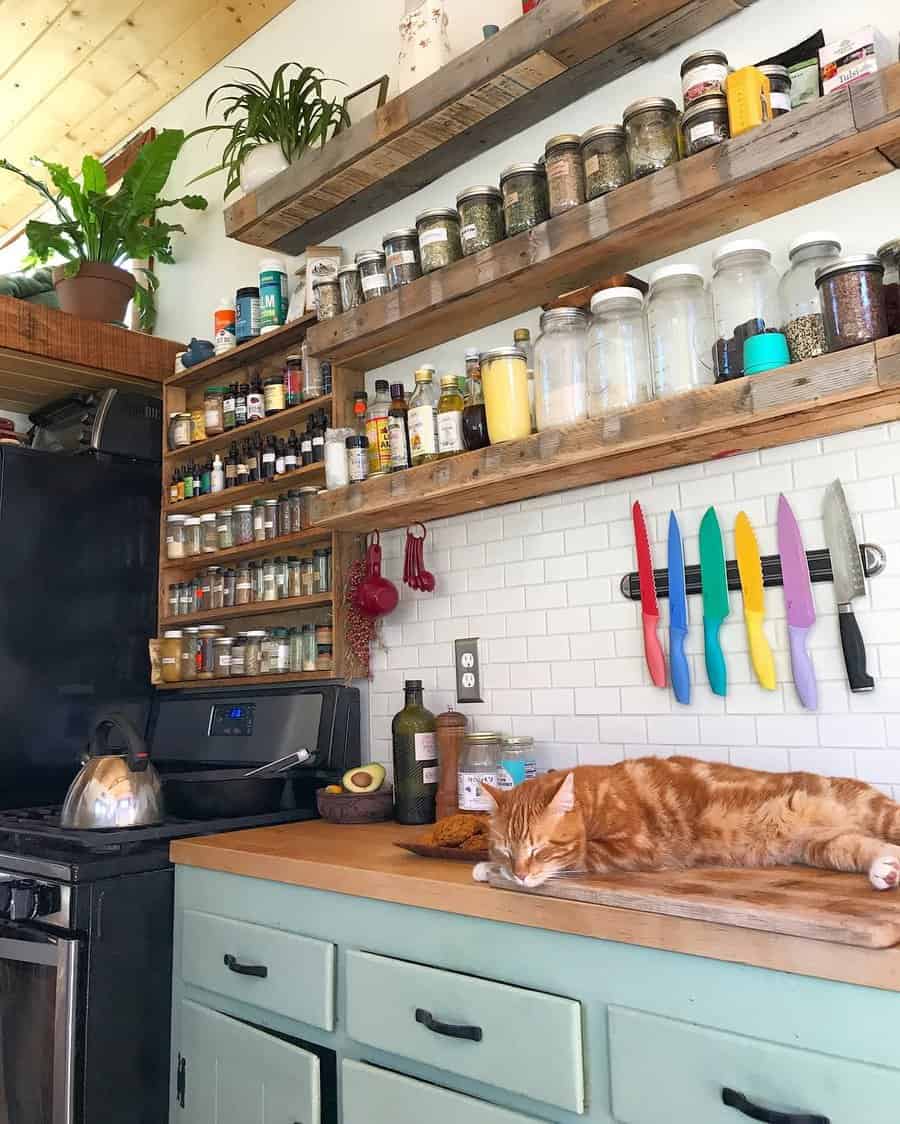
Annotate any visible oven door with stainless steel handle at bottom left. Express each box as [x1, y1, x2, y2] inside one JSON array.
[[0, 922, 80, 1124]]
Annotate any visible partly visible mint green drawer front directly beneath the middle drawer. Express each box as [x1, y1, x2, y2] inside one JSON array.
[[340, 1061, 534, 1124]]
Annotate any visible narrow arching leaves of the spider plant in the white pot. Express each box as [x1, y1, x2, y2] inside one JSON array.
[[191, 63, 349, 199]]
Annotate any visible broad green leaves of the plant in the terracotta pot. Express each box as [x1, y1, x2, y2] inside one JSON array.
[[0, 129, 207, 330]]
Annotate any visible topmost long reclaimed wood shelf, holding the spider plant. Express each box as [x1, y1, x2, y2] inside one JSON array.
[[225, 0, 753, 254]]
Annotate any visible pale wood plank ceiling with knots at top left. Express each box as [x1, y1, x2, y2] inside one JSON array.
[[0, 0, 291, 233]]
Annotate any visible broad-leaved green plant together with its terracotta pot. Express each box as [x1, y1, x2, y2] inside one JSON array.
[[0, 129, 207, 330]]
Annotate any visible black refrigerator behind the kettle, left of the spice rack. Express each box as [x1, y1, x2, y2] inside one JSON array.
[[0, 445, 161, 808]]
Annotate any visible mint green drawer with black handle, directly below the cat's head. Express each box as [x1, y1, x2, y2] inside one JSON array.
[[347, 952, 584, 1113]]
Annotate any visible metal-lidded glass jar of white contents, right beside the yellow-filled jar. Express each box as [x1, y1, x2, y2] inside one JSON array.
[[535, 308, 588, 433]]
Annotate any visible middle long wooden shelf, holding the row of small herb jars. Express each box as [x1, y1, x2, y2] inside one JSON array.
[[309, 66, 900, 370]]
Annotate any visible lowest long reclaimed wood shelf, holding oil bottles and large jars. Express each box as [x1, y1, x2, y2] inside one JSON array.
[[312, 336, 900, 532]]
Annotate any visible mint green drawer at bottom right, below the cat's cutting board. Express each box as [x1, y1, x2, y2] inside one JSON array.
[[609, 1007, 900, 1124]]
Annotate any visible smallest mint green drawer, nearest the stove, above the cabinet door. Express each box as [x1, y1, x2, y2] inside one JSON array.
[[181, 909, 335, 1031]]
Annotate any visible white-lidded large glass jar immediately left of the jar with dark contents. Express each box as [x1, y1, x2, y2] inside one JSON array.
[[646, 265, 716, 398]]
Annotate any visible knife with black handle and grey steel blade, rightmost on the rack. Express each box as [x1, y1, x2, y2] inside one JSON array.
[[825, 480, 875, 691]]
